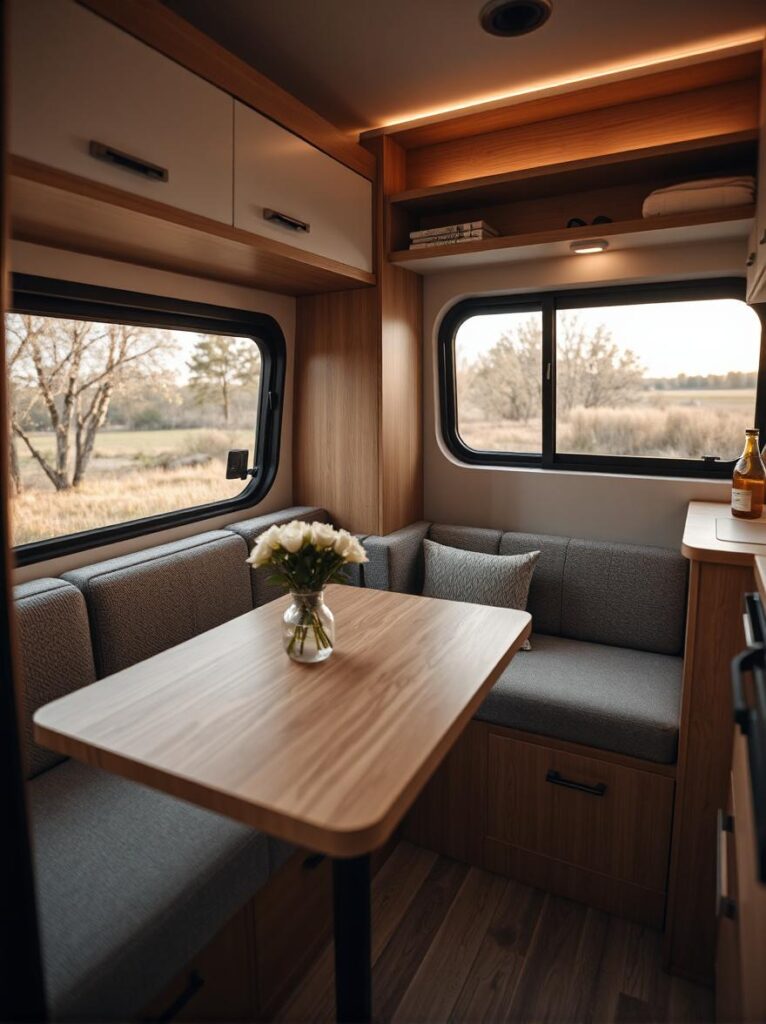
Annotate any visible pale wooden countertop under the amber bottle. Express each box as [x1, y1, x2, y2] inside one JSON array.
[[681, 502, 766, 565]]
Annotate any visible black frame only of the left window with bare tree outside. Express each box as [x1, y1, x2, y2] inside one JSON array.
[[7, 273, 287, 566]]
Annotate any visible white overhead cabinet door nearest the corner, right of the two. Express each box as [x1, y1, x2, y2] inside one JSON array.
[[235, 102, 373, 270]]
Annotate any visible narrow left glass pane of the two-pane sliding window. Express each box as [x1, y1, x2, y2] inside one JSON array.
[[455, 310, 543, 454]]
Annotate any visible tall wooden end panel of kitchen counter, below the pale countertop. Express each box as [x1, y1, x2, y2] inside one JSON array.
[[666, 561, 755, 984]]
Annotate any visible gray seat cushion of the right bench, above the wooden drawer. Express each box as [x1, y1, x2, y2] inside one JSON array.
[[476, 634, 683, 764]]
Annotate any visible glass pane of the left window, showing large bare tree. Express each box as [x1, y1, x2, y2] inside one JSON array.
[[6, 313, 261, 545]]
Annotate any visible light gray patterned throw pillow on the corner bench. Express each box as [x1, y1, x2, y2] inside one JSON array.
[[423, 541, 540, 650]]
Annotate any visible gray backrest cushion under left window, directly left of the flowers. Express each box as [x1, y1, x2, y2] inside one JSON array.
[[63, 529, 253, 678]]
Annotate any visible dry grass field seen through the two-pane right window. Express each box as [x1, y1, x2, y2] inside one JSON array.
[[460, 389, 755, 460]]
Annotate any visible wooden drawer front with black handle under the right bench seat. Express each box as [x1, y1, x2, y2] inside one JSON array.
[[487, 733, 674, 892]]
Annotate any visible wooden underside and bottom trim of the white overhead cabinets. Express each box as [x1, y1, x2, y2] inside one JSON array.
[[9, 157, 376, 295]]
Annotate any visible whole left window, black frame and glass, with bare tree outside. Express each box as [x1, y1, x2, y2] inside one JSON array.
[[5, 274, 286, 565]]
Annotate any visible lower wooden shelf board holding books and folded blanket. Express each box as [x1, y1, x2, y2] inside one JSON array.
[[389, 206, 756, 272]]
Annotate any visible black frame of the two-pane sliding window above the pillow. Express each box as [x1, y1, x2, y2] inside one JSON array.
[[437, 278, 766, 479]]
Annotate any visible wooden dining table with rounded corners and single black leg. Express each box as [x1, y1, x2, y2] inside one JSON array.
[[35, 585, 530, 1021]]
